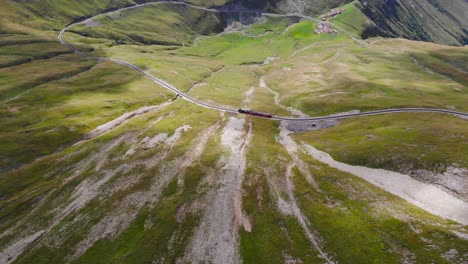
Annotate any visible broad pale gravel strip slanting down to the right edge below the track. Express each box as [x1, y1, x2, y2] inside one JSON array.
[[303, 143, 468, 225]]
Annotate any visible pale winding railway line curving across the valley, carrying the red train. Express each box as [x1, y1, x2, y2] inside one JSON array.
[[58, 1, 468, 121]]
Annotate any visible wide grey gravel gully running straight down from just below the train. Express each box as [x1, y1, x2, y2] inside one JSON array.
[[185, 117, 252, 264]]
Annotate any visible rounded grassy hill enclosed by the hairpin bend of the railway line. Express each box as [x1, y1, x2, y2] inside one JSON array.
[[73, 5, 225, 45]]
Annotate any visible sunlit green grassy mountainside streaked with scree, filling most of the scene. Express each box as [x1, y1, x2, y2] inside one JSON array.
[[0, 0, 468, 264]]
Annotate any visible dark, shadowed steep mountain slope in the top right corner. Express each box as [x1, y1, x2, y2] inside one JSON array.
[[360, 0, 468, 45]]
